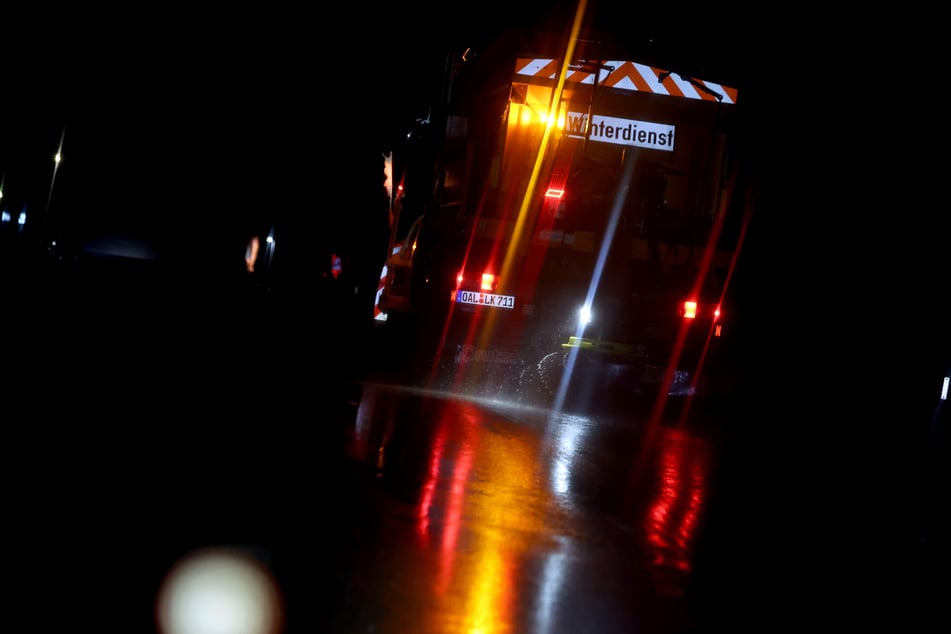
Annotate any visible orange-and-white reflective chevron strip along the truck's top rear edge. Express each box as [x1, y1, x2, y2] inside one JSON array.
[[515, 58, 737, 104]]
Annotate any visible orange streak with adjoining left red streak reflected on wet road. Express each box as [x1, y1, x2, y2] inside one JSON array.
[[417, 403, 547, 632]]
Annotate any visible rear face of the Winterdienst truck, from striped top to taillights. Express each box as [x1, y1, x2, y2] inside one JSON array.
[[424, 51, 742, 401]]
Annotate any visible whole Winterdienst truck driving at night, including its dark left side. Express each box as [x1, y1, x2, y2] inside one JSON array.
[[378, 29, 753, 406]]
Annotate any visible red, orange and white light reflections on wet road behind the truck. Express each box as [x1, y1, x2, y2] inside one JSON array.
[[341, 384, 714, 633]]
